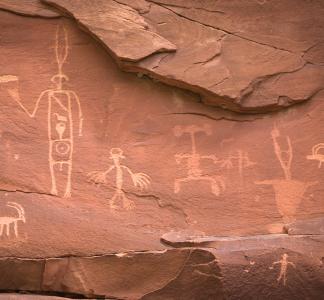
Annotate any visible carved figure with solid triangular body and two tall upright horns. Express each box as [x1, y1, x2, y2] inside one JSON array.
[[255, 126, 317, 223]]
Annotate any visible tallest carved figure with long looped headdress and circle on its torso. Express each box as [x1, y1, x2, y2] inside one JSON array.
[[0, 26, 83, 198]]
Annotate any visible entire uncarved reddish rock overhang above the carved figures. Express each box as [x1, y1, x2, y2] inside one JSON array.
[[42, 0, 324, 112]]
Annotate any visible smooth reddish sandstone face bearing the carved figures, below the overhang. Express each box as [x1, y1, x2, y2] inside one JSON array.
[[0, 7, 324, 258]]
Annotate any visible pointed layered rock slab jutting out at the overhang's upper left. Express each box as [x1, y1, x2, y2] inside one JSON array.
[[45, 0, 176, 61]]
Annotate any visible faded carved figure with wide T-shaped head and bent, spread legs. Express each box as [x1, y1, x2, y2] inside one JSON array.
[[174, 125, 225, 196]]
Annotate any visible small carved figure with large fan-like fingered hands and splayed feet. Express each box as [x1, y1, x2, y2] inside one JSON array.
[[88, 148, 151, 210]]
